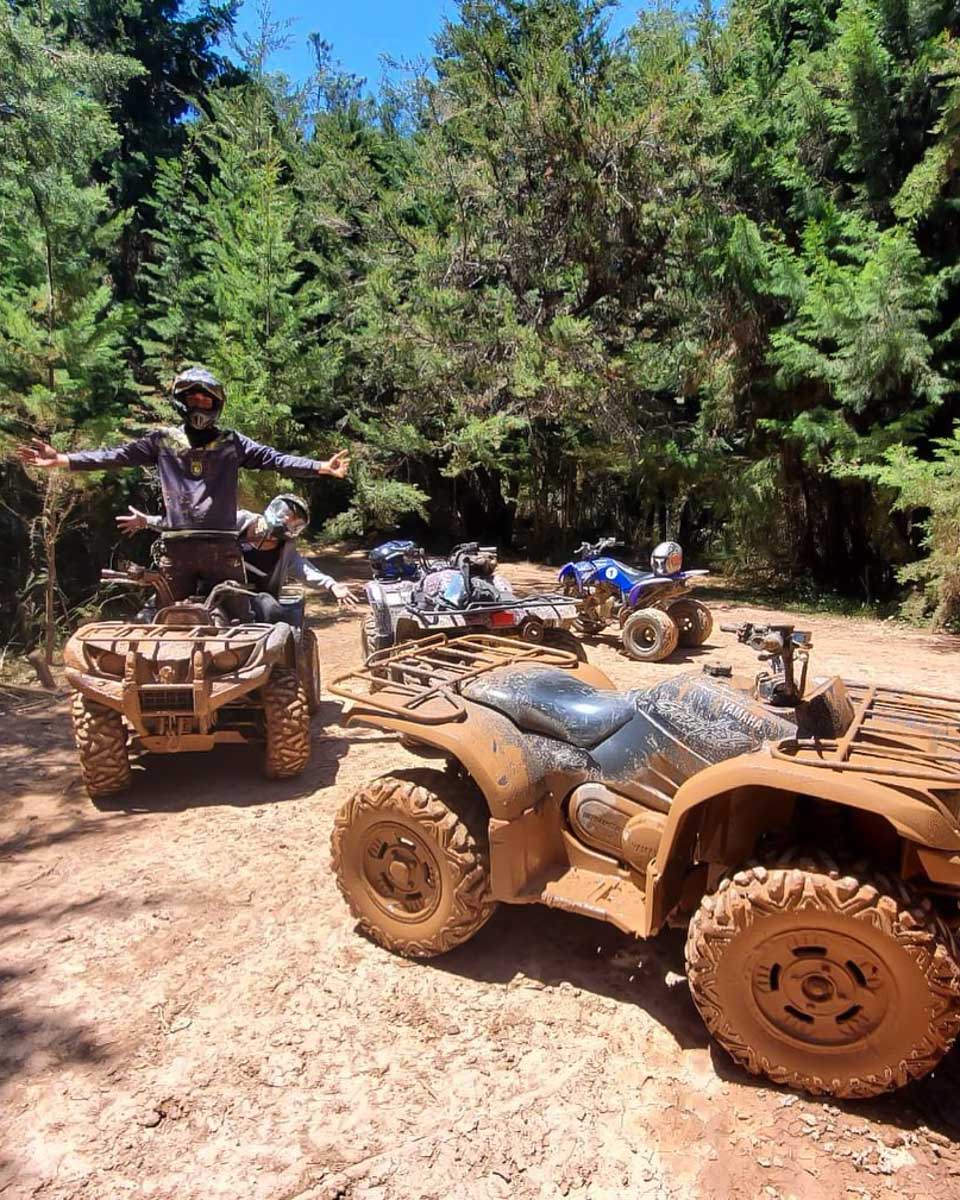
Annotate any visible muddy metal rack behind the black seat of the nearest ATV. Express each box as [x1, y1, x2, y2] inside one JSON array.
[[329, 634, 578, 725]]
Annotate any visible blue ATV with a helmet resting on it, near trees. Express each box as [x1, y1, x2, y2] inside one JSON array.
[[559, 538, 713, 662]]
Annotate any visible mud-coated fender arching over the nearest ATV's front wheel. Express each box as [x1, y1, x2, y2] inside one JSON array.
[[644, 745, 960, 936]]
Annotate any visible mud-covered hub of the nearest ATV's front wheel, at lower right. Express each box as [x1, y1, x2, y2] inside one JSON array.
[[750, 930, 895, 1046]]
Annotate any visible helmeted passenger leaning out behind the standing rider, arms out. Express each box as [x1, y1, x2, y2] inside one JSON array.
[[116, 493, 359, 620]]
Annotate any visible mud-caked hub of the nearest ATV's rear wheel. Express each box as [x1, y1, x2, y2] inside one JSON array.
[[364, 821, 440, 920]]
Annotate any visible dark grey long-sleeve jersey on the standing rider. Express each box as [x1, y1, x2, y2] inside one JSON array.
[[67, 426, 320, 529]]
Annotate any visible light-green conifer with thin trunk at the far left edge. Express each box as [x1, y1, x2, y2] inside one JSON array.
[[0, 7, 139, 662]]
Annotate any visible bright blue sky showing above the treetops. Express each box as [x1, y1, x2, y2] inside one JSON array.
[[229, 0, 638, 91]]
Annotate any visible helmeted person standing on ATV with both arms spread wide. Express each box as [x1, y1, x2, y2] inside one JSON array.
[[17, 366, 350, 599]]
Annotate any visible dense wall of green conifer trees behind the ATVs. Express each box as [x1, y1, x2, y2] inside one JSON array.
[[0, 0, 960, 662]]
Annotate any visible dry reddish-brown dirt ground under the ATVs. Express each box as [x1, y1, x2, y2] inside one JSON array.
[[0, 556, 960, 1200]]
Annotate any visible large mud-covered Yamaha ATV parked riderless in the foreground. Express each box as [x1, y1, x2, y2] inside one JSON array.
[[331, 625, 960, 1098]]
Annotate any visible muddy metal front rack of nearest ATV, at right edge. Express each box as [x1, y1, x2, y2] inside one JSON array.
[[772, 683, 960, 786]]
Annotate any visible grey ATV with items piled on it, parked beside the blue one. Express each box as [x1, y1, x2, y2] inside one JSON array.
[[360, 541, 586, 660]]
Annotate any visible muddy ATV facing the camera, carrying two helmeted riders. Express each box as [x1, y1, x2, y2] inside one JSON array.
[[64, 530, 320, 800]]
